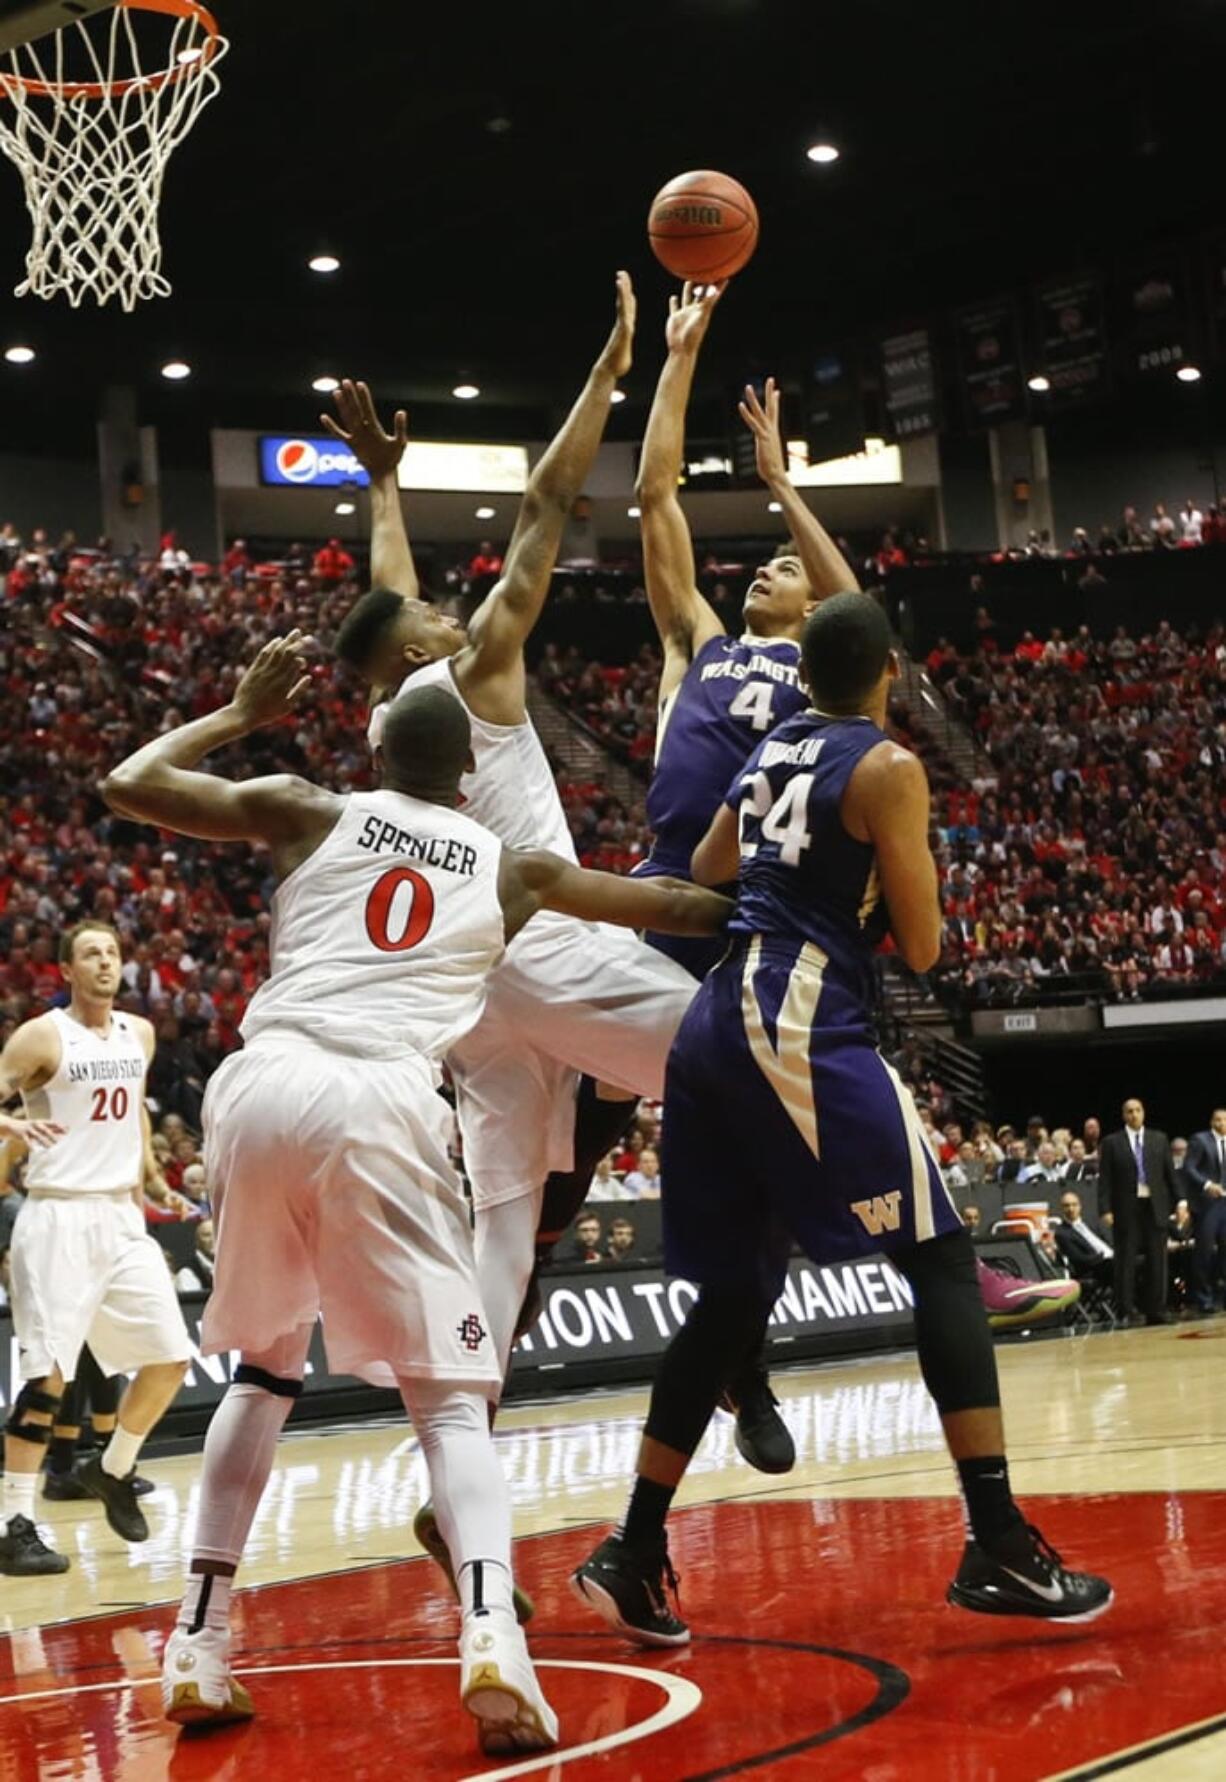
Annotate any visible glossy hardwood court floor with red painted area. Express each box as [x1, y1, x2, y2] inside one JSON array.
[[0, 1320, 1226, 1782]]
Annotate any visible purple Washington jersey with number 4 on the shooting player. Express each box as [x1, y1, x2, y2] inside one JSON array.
[[647, 636, 805, 877]]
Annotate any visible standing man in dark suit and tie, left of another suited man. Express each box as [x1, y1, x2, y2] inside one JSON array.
[[1099, 1096, 1178, 1324]]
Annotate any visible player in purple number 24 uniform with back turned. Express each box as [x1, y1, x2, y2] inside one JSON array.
[[574, 593, 1112, 1647]]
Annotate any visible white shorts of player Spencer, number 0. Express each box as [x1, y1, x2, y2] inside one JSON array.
[[201, 1016, 501, 1390]]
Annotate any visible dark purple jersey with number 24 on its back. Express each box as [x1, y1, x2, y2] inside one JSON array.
[[725, 709, 889, 1028]]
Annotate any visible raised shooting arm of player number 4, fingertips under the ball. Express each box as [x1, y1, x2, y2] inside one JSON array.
[[634, 282, 725, 702]]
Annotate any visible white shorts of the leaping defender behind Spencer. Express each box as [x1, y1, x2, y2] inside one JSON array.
[[447, 914, 699, 1208]]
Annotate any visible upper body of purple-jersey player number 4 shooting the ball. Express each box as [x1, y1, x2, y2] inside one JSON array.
[[638, 285, 857, 977]]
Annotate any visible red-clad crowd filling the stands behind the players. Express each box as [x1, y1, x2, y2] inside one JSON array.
[[0, 526, 1226, 1283]]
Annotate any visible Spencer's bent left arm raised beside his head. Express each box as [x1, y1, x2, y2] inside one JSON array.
[[100, 631, 336, 873]]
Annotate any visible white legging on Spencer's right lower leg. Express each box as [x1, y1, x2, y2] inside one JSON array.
[[399, 1375, 511, 1616]]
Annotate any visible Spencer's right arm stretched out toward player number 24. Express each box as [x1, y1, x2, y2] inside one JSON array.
[[499, 848, 732, 941]]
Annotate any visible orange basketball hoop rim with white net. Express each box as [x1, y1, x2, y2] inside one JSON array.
[[0, 0, 230, 310]]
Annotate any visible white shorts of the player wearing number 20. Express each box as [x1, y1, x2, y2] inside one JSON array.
[[12, 1192, 192, 1381]]
